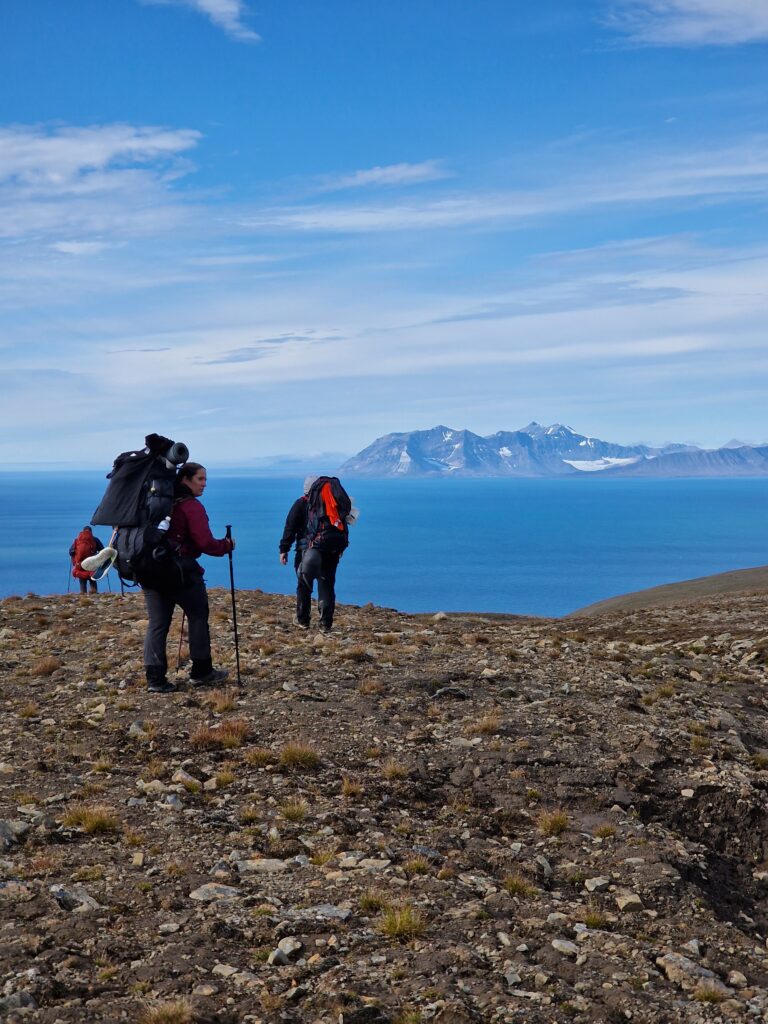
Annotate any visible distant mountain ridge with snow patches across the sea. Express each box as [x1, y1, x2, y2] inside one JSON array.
[[339, 422, 768, 477]]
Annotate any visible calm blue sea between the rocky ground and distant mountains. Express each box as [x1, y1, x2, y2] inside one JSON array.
[[0, 468, 768, 615]]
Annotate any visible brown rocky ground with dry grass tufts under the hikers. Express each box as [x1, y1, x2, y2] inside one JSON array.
[[0, 592, 768, 1024]]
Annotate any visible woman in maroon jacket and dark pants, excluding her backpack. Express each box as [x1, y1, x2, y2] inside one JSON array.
[[143, 462, 234, 693]]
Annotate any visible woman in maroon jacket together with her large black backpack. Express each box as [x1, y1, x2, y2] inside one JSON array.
[[91, 434, 234, 693]]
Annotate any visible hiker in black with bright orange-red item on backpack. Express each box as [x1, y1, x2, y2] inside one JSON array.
[[280, 476, 353, 633]]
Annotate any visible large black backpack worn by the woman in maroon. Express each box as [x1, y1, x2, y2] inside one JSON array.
[[91, 434, 189, 590]]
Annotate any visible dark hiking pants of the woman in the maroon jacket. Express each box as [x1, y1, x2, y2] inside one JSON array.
[[144, 566, 213, 681]]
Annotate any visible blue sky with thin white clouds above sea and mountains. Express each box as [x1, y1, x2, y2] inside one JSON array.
[[0, 0, 768, 465]]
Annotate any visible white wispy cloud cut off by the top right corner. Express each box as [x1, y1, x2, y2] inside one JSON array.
[[605, 0, 768, 46]]
